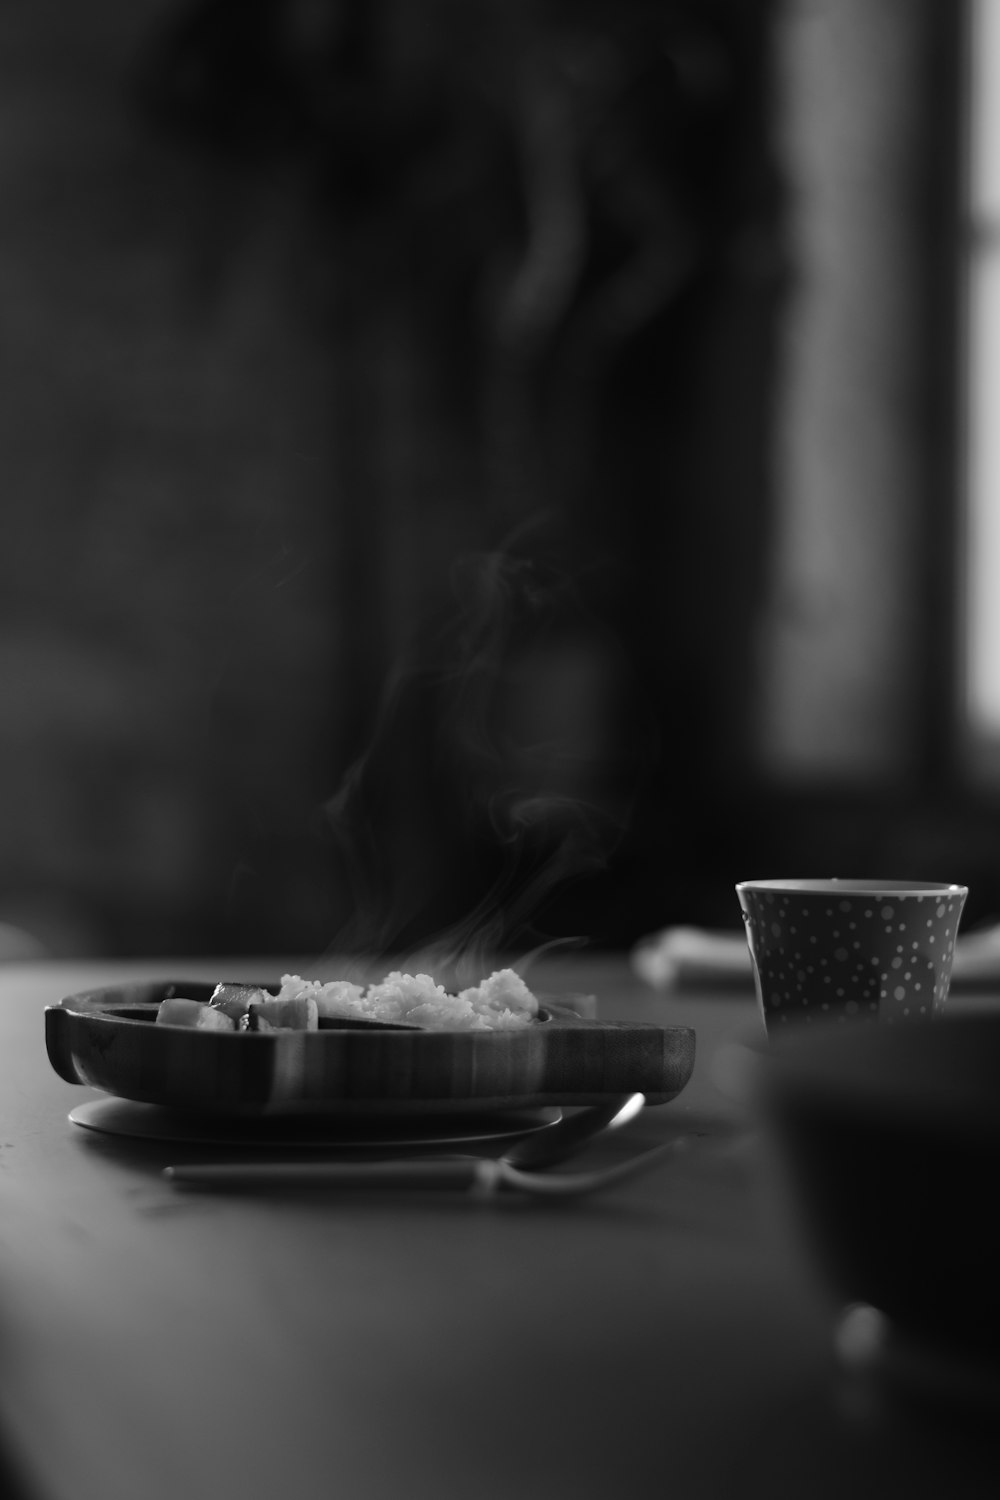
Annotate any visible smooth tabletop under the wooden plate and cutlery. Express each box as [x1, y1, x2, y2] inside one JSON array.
[[0, 959, 996, 1500]]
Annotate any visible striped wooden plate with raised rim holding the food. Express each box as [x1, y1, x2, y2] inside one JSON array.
[[45, 981, 694, 1116]]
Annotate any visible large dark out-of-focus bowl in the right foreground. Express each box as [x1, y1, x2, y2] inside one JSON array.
[[753, 1016, 1000, 1361]]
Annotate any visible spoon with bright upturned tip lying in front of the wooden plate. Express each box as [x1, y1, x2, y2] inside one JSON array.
[[163, 1094, 646, 1197]]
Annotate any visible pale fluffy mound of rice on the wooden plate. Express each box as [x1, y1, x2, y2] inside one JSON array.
[[277, 969, 538, 1031]]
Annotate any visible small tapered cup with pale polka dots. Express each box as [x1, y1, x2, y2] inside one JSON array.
[[736, 881, 969, 1037]]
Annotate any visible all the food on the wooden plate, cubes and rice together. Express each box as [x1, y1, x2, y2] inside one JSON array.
[[156, 969, 538, 1031]]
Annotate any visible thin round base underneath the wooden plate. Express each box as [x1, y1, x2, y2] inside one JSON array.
[[69, 1098, 562, 1151]]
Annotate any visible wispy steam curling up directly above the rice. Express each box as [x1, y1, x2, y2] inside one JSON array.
[[325, 552, 631, 986]]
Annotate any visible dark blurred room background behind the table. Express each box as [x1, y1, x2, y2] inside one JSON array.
[[0, 0, 1000, 956]]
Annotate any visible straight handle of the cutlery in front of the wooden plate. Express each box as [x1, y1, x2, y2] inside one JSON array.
[[163, 1158, 502, 1196]]
